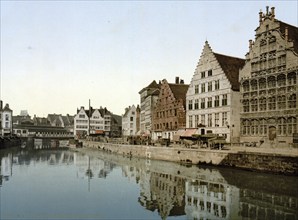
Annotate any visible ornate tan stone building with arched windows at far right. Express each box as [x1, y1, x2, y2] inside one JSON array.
[[239, 7, 298, 147]]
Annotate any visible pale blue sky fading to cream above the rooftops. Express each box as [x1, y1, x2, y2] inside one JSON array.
[[0, 0, 298, 117]]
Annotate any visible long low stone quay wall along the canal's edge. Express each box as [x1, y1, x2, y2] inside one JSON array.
[[83, 141, 298, 175]]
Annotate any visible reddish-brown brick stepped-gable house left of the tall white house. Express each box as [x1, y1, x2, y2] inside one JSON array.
[[152, 77, 189, 140]]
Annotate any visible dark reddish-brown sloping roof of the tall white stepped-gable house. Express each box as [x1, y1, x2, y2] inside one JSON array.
[[214, 53, 245, 91]]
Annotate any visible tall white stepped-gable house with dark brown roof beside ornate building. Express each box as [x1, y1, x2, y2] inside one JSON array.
[[186, 41, 244, 142]]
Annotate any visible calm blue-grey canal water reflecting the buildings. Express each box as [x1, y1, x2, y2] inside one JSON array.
[[0, 142, 298, 220]]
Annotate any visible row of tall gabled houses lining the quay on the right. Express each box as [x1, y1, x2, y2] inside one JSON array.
[[122, 7, 298, 146]]
